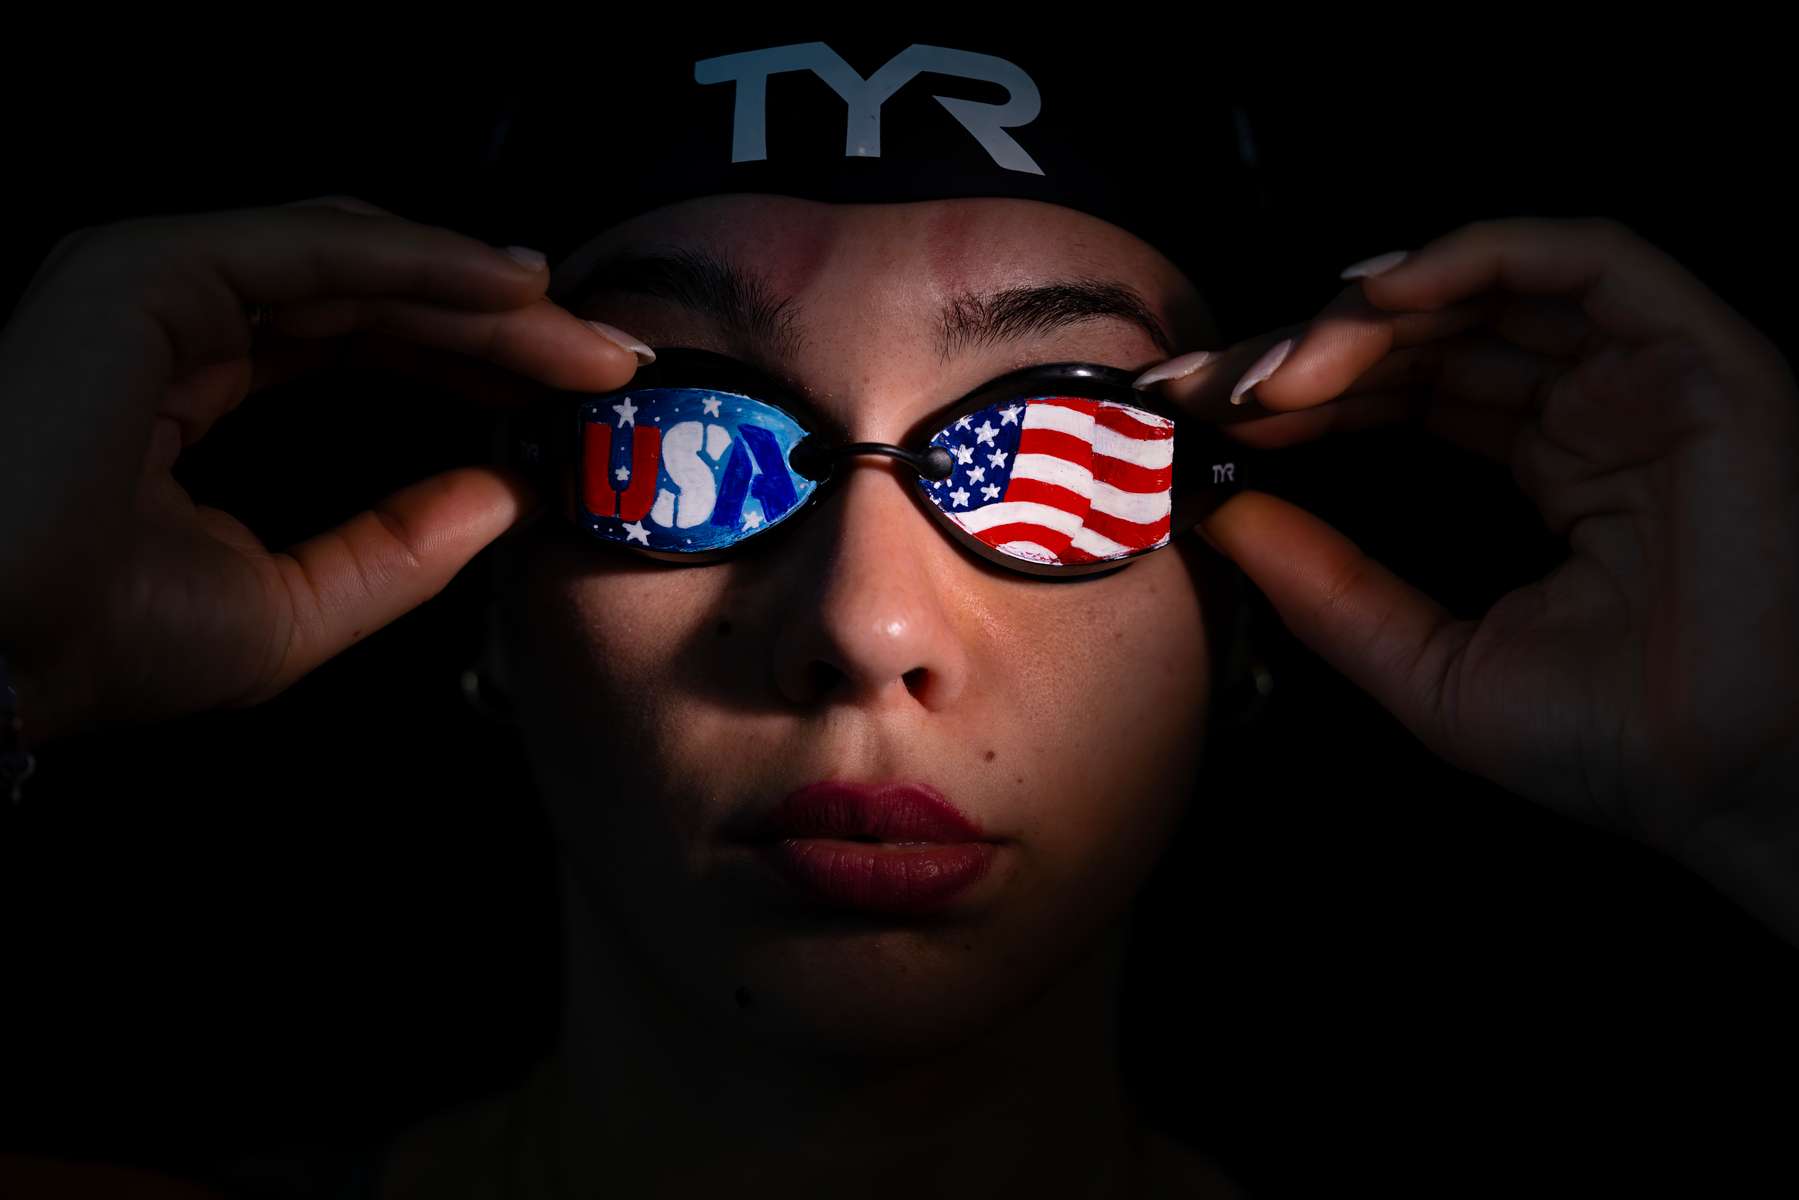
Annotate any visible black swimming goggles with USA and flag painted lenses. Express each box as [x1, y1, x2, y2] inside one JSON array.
[[500, 347, 1259, 578]]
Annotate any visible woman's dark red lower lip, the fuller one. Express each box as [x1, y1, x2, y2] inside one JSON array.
[[756, 838, 998, 914]]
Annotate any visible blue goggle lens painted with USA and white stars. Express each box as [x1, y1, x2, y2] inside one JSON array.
[[577, 387, 819, 554]]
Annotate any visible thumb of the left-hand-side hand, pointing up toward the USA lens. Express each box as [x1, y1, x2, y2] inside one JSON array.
[[250, 466, 540, 705]]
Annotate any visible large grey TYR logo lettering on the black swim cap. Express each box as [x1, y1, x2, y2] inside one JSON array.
[[693, 41, 1043, 175]]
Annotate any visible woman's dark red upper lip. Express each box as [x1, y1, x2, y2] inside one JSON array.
[[743, 779, 989, 842]]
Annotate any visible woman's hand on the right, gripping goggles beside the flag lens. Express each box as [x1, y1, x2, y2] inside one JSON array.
[[1160, 219, 1799, 930]]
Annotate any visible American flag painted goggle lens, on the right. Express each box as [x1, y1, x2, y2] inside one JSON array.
[[921, 396, 1175, 563]]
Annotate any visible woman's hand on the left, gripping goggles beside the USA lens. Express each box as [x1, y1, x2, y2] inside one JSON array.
[[0, 196, 637, 743]]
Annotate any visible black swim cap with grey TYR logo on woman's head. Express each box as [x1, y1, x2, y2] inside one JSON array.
[[479, 28, 1263, 318]]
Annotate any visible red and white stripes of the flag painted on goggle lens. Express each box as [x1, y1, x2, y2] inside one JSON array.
[[955, 396, 1175, 563]]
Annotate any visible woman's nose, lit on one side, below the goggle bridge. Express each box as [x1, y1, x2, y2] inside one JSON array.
[[774, 455, 968, 709]]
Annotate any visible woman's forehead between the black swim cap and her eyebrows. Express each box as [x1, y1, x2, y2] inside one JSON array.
[[550, 194, 1198, 329]]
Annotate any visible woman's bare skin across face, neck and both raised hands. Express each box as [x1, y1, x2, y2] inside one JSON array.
[[0, 39, 1795, 1195]]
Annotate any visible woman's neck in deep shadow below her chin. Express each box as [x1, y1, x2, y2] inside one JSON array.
[[520, 859, 1137, 1200]]
